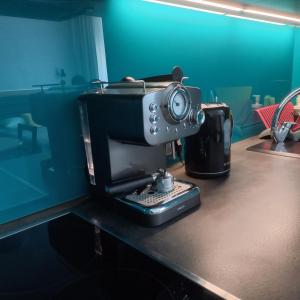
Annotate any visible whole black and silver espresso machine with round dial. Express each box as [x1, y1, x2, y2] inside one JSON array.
[[80, 67, 204, 226]]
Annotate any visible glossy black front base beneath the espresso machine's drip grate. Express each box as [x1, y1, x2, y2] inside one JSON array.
[[115, 186, 201, 227]]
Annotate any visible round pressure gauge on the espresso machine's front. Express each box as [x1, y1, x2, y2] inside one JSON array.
[[168, 87, 191, 122]]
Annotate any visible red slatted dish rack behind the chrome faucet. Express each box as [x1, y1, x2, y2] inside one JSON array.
[[256, 102, 300, 132]]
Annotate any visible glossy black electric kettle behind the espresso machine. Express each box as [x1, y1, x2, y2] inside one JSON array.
[[185, 103, 233, 178]]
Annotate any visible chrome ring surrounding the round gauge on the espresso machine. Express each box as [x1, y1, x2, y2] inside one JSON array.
[[167, 86, 191, 123]]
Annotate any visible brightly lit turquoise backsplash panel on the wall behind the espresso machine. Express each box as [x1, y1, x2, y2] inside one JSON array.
[[99, 0, 294, 139]]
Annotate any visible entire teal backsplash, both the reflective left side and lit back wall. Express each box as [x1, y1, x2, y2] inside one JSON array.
[[0, 0, 299, 224]]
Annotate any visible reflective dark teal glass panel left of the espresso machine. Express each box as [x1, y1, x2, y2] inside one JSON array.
[[0, 5, 107, 224]]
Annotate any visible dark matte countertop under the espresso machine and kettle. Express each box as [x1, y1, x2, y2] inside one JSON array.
[[76, 138, 300, 300]]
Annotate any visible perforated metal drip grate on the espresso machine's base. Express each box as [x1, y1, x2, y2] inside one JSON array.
[[125, 181, 193, 207]]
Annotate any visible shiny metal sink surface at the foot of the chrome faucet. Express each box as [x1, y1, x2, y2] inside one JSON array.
[[247, 140, 300, 159]]
